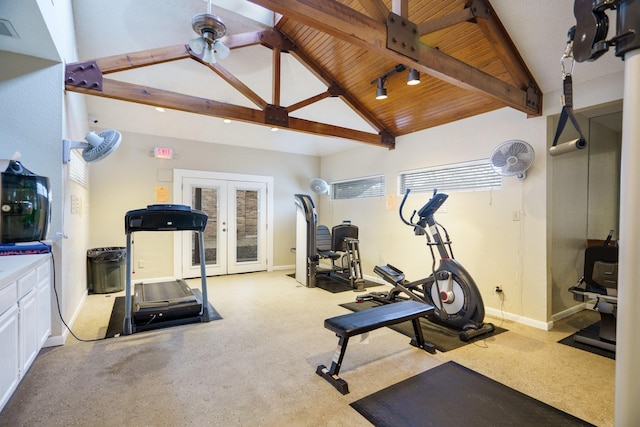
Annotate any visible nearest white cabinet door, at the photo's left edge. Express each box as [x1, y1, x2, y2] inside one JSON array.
[[0, 303, 20, 411]]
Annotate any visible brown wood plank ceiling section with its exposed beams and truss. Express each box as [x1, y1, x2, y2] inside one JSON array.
[[65, 0, 542, 149]]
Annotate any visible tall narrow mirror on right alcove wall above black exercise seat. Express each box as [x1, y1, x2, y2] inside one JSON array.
[[587, 112, 622, 240]]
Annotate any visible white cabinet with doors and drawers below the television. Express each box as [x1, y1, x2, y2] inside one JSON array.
[[0, 254, 52, 411]]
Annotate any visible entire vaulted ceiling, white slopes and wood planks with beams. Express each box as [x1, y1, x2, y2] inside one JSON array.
[[0, 0, 624, 156]]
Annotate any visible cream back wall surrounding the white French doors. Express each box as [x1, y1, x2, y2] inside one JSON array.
[[89, 133, 320, 280]]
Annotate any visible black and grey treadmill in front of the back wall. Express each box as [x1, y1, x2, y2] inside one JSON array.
[[122, 204, 210, 335]]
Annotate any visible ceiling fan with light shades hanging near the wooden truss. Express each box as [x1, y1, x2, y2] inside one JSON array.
[[189, 0, 229, 64]]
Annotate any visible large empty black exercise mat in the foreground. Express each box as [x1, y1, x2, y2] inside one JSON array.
[[351, 362, 592, 427]]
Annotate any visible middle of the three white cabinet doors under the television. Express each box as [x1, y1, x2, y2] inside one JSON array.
[[18, 289, 40, 377]]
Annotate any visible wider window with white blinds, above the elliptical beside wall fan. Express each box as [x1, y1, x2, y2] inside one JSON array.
[[398, 159, 502, 194]]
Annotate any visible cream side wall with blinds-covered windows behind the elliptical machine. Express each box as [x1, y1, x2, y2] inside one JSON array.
[[320, 109, 547, 326]]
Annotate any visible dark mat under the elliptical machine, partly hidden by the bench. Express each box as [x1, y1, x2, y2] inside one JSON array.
[[340, 301, 507, 353]]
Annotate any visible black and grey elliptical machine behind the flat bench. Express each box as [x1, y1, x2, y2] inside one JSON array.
[[356, 189, 494, 342]]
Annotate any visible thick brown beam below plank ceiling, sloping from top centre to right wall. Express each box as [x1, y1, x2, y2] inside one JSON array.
[[250, 0, 542, 115]]
